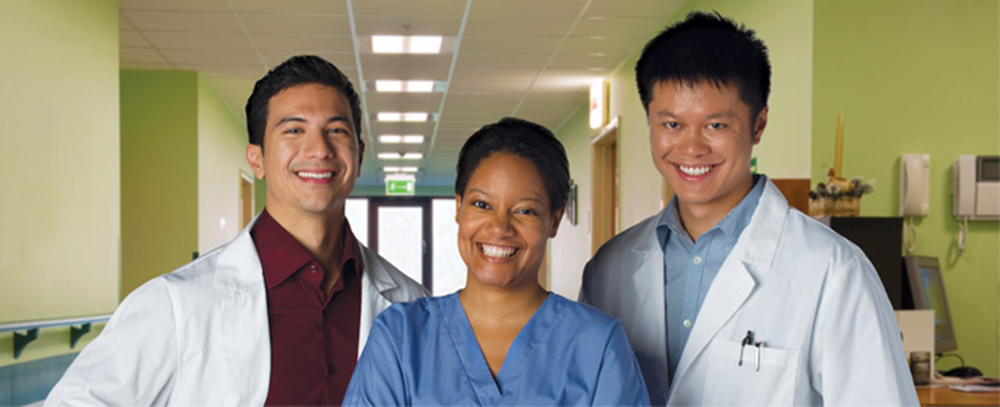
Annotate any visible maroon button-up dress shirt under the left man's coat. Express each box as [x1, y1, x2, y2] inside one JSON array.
[[250, 209, 362, 405]]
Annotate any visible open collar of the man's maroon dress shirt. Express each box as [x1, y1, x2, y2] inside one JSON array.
[[250, 209, 362, 288]]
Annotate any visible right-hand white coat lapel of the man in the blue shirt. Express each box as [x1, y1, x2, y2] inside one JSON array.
[[674, 179, 788, 392]]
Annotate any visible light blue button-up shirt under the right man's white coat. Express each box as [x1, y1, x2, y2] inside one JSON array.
[[656, 175, 767, 380]]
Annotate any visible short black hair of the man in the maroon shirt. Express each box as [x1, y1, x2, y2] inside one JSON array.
[[246, 55, 361, 146]]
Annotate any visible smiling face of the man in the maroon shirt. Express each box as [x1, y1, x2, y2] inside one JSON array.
[[247, 84, 364, 223]]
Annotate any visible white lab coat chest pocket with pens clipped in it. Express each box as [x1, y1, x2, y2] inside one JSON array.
[[703, 340, 799, 406]]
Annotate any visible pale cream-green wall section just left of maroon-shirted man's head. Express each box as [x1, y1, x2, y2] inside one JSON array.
[[198, 75, 254, 253]]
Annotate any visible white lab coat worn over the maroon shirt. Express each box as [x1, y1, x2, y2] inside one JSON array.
[[45, 220, 427, 406]]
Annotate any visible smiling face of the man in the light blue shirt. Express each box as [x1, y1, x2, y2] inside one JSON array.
[[649, 81, 767, 220]]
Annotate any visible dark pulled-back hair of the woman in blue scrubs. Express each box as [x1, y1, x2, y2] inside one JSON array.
[[455, 117, 569, 213]]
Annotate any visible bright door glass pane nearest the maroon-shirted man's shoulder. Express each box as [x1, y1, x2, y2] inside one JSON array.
[[378, 206, 424, 284]]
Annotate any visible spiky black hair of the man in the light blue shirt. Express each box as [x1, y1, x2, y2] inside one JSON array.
[[635, 11, 771, 120]]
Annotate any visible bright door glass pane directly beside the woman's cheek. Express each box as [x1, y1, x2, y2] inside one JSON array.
[[431, 199, 467, 295]]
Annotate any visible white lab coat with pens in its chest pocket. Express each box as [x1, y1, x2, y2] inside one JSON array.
[[580, 180, 918, 405]]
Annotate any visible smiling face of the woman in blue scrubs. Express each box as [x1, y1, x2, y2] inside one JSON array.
[[455, 153, 562, 289]]
